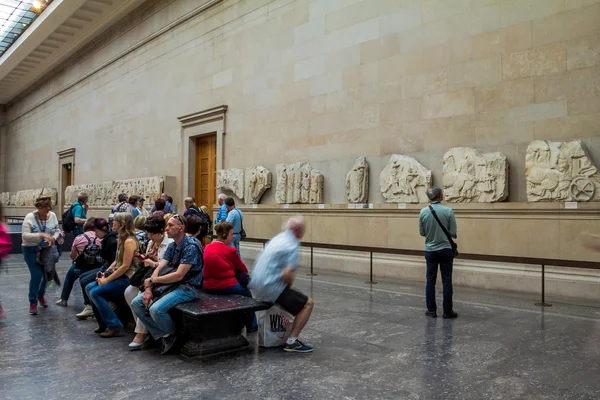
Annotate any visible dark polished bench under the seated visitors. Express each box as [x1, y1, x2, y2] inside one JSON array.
[[169, 292, 272, 358]]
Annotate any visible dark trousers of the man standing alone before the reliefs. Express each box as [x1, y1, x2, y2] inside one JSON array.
[[425, 249, 454, 314]]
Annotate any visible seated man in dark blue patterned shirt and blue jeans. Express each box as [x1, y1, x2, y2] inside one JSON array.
[[131, 215, 203, 354]]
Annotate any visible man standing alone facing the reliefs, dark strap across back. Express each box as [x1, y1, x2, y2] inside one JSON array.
[[419, 186, 458, 318]]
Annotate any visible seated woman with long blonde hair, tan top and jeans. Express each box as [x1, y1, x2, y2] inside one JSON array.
[[85, 213, 138, 338]]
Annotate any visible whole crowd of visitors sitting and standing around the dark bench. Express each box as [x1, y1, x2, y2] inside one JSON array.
[[8, 193, 313, 354]]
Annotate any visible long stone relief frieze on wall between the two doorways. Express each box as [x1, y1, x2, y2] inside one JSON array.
[[65, 176, 164, 208]]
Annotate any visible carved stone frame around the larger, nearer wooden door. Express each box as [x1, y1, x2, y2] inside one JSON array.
[[177, 105, 227, 207]]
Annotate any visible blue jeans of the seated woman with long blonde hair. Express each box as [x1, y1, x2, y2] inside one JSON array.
[[85, 276, 129, 329]]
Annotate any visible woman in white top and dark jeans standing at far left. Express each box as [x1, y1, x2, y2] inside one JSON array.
[[21, 196, 61, 315]]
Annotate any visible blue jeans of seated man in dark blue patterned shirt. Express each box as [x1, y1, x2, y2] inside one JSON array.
[[131, 285, 197, 339]]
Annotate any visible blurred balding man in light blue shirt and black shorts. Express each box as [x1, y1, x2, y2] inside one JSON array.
[[248, 218, 313, 353]]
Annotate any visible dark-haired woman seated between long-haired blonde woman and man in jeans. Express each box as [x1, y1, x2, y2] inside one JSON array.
[[125, 217, 173, 350]]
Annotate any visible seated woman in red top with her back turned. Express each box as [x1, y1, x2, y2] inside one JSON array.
[[203, 222, 258, 333]]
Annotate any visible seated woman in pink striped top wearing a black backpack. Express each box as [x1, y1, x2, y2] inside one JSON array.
[[56, 218, 102, 307]]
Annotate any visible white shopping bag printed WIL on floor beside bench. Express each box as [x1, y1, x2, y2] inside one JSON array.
[[257, 306, 294, 347]]
